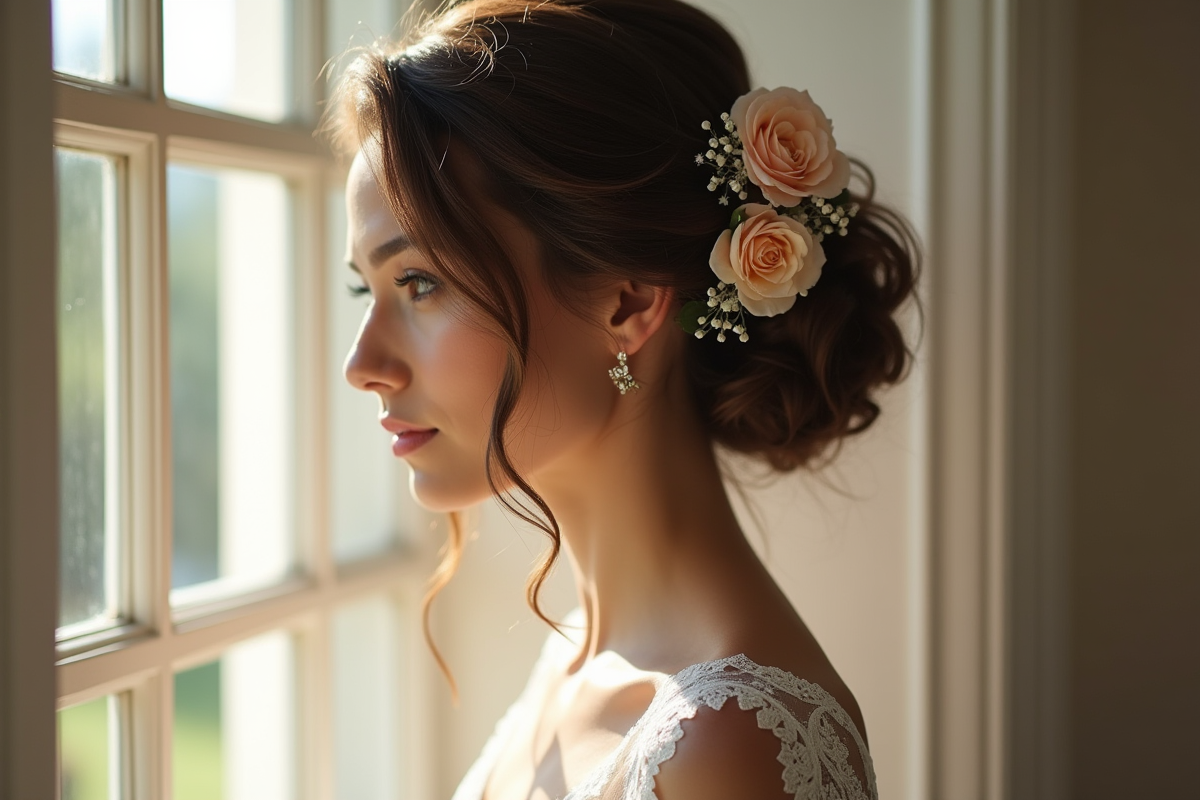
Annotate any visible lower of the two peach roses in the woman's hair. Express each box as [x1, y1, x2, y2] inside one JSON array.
[[708, 203, 824, 317]]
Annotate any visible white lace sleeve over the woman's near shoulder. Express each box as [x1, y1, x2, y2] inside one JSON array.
[[623, 656, 877, 800]]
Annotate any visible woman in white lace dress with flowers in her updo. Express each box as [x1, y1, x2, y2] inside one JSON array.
[[331, 0, 914, 800]]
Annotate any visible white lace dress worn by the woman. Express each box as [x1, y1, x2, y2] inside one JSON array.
[[452, 618, 878, 800]]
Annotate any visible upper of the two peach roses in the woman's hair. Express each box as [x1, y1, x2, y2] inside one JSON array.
[[732, 86, 850, 206]]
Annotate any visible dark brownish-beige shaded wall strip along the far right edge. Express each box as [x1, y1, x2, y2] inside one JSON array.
[[1067, 0, 1200, 800]]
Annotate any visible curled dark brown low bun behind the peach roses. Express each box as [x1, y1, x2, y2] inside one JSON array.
[[688, 164, 918, 471]]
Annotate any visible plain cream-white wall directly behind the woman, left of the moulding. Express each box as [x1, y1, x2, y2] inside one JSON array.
[[429, 0, 928, 799]]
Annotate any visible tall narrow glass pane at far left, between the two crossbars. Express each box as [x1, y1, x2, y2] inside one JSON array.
[[55, 149, 119, 627]]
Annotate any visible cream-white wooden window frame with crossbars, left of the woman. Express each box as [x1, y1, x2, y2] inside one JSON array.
[[0, 0, 433, 799]]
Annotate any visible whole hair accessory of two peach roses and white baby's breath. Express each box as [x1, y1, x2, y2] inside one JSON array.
[[678, 86, 858, 342]]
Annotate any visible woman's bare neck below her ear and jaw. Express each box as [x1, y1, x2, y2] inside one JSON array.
[[533, 359, 766, 663]]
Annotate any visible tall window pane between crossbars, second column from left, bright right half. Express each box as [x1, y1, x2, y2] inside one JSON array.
[[167, 164, 294, 602]]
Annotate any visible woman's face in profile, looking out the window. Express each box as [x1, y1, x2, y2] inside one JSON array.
[[346, 154, 616, 511]]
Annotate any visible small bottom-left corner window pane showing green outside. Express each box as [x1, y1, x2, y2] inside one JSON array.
[[59, 694, 118, 800]]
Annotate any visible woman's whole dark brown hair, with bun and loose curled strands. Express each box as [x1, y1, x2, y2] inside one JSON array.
[[328, 0, 917, 681]]
